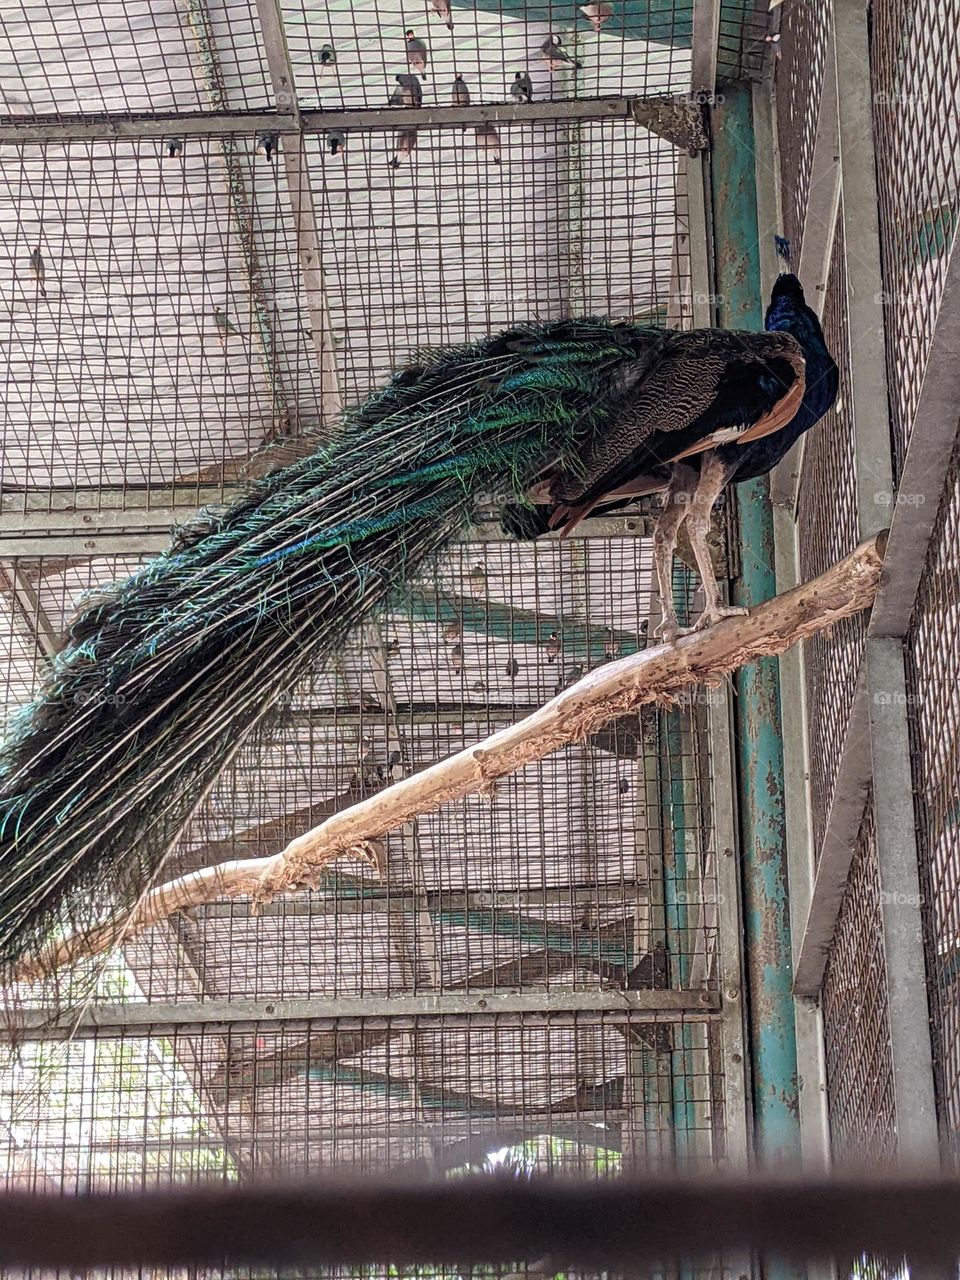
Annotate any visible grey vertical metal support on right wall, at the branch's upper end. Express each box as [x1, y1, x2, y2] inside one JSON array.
[[835, 0, 938, 1161]]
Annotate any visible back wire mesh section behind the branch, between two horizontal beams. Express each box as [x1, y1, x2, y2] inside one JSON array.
[[5, 538, 719, 1000]]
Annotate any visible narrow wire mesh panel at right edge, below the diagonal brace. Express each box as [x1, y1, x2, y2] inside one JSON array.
[[906, 435, 960, 1160]]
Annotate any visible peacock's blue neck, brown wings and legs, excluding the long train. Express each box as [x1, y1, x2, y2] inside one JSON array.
[[502, 236, 840, 641]]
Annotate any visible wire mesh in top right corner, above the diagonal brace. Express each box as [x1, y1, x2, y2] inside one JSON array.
[[870, 0, 960, 475]]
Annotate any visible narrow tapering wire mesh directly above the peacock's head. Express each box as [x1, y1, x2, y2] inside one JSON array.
[[774, 0, 833, 262]]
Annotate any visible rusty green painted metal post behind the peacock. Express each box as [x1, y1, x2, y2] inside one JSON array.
[[712, 84, 800, 1164]]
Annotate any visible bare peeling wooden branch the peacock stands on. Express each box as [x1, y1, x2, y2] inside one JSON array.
[[15, 532, 886, 982]]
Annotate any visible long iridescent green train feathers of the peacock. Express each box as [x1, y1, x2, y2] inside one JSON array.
[[0, 320, 662, 972]]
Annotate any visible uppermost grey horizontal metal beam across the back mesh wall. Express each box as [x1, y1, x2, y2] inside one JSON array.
[[0, 95, 705, 146]]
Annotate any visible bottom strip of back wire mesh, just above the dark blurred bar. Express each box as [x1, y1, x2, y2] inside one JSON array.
[[0, 1011, 723, 1194]]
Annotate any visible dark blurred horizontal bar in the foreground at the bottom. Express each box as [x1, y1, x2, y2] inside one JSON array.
[[0, 1174, 960, 1274]]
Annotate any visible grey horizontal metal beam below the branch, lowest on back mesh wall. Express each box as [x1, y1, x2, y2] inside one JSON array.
[[9, 989, 719, 1041]]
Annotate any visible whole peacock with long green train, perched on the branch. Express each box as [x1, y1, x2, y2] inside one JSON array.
[[0, 238, 832, 974]]
